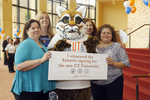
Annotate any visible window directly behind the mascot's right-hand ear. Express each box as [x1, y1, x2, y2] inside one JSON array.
[[76, 0, 96, 22]]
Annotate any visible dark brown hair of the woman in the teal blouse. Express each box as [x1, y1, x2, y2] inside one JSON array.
[[23, 19, 41, 40]]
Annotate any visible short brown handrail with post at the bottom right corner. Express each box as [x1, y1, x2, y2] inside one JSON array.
[[132, 74, 150, 100]]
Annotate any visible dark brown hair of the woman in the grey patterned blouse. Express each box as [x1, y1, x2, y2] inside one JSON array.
[[96, 24, 117, 42]]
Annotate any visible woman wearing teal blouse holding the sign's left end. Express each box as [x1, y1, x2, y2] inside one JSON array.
[[11, 19, 55, 100]]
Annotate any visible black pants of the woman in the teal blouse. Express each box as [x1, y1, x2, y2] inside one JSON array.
[[13, 91, 49, 100]]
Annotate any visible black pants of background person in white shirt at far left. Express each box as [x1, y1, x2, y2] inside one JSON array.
[[7, 53, 14, 72]]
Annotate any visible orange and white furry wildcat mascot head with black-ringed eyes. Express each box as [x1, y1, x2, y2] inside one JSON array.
[[56, 6, 86, 40]]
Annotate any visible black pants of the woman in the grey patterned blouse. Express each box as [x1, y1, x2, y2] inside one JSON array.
[[91, 75, 124, 100]]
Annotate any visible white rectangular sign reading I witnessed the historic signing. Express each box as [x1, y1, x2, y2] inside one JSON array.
[[48, 51, 108, 80]]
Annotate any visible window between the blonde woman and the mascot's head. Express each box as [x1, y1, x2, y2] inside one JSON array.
[[47, 0, 68, 34]]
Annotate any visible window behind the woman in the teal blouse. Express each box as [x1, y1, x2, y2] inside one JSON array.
[[12, 0, 37, 36]]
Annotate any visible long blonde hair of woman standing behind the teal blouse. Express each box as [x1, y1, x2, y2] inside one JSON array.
[[35, 11, 54, 38]]
